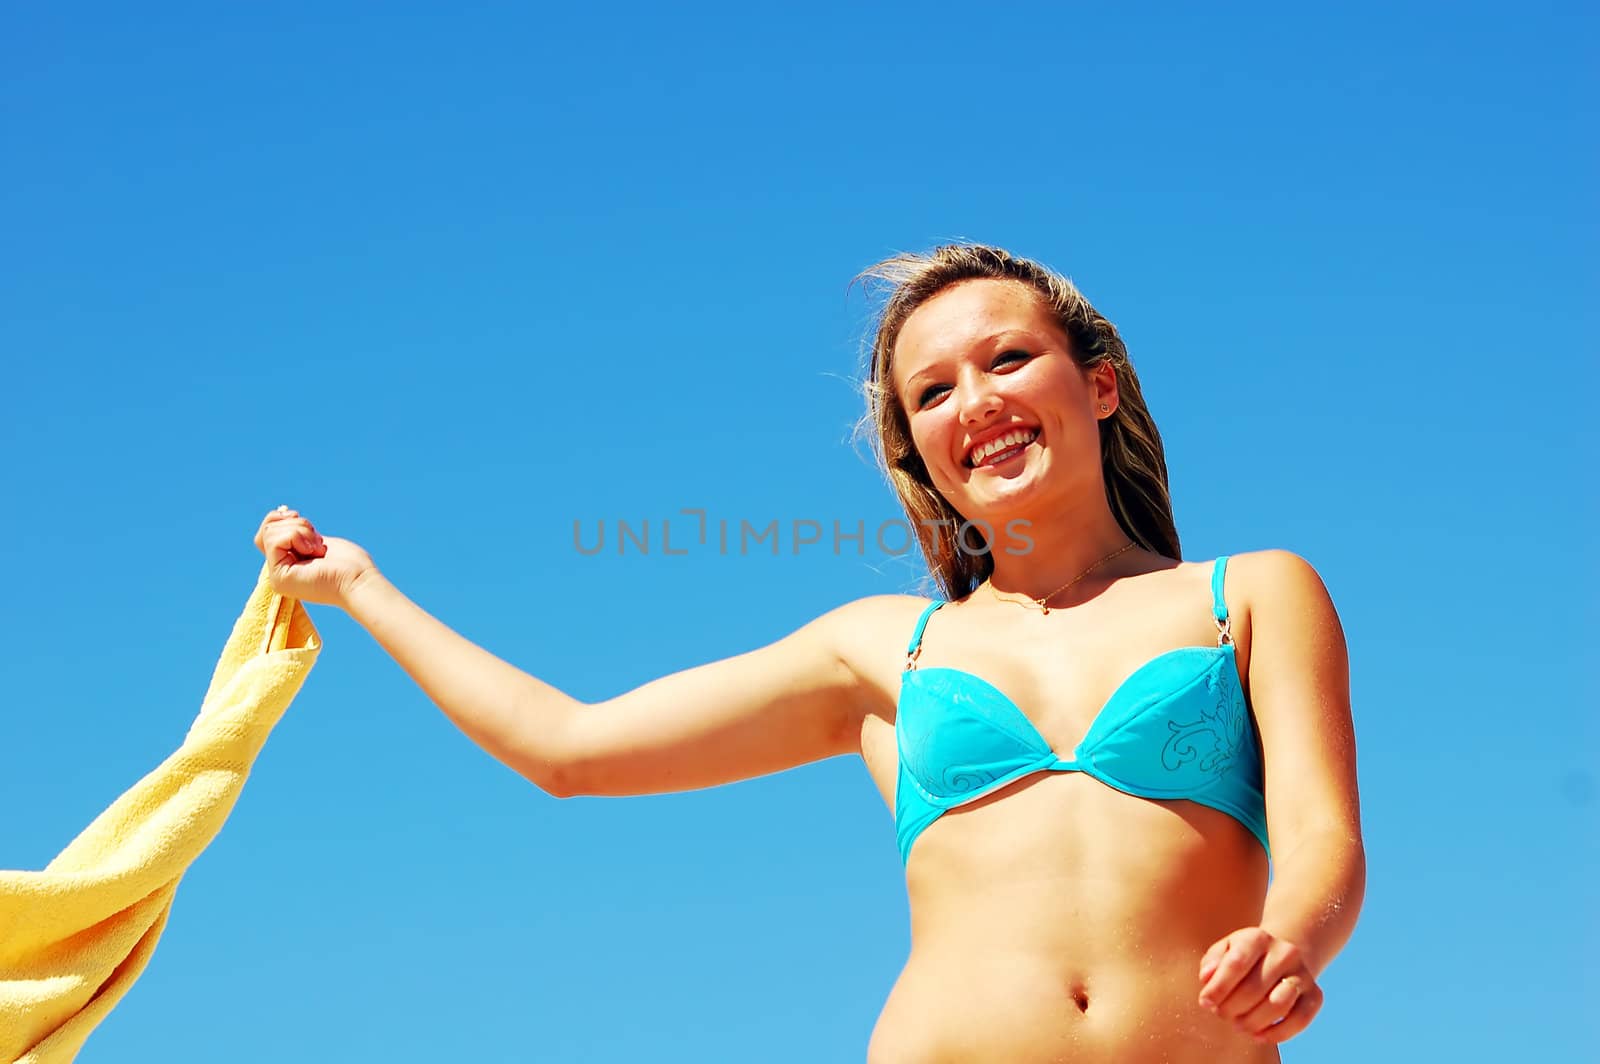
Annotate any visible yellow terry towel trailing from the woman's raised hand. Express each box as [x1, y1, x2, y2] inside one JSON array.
[[0, 565, 322, 1064]]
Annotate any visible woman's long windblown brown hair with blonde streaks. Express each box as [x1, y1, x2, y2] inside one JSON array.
[[856, 243, 1182, 598]]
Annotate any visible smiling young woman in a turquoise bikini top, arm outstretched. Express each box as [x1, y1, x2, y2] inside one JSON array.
[[256, 245, 1365, 1064]]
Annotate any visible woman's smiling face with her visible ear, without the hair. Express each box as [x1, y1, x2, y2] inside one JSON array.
[[891, 280, 1117, 528]]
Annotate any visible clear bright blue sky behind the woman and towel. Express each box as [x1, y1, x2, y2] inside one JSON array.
[[0, 2, 1600, 1064]]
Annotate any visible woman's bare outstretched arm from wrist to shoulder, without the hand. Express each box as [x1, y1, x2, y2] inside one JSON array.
[[339, 568, 893, 797]]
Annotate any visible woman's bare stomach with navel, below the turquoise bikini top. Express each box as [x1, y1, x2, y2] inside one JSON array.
[[867, 773, 1278, 1064]]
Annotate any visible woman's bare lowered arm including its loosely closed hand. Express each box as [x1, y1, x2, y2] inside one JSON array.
[[1200, 550, 1366, 1042]]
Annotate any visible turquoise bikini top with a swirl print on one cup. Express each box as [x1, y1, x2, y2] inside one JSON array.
[[894, 557, 1272, 861]]
